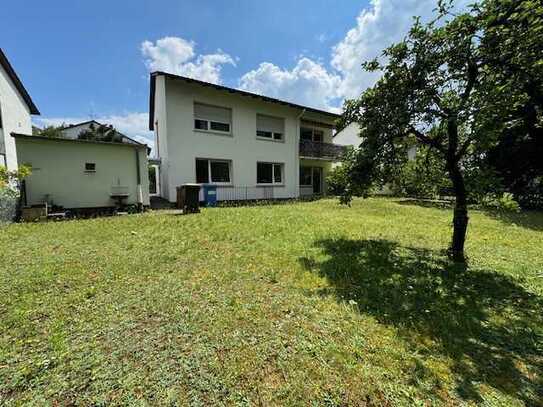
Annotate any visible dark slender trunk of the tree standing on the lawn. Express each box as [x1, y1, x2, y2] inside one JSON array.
[[447, 117, 469, 263]]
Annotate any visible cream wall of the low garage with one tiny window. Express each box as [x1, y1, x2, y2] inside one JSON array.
[[16, 138, 149, 208]]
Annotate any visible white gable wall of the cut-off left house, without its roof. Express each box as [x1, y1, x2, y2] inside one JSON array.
[[0, 66, 32, 170]]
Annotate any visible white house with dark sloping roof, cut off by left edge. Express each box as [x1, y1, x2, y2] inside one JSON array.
[[0, 48, 40, 170]]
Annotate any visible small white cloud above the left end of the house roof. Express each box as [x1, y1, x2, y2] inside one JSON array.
[[141, 37, 236, 84]]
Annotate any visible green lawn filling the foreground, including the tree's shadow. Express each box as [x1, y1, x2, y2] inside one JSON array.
[[0, 199, 543, 406]]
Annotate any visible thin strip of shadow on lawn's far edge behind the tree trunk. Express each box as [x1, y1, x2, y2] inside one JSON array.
[[394, 198, 543, 231]]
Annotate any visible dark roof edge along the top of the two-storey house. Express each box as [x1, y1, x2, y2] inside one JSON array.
[[149, 71, 341, 130]]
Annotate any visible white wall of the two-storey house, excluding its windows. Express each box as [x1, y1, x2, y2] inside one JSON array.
[[155, 76, 333, 201]]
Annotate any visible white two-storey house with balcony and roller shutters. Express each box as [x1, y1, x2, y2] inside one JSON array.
[[149, 72, 343, 201]]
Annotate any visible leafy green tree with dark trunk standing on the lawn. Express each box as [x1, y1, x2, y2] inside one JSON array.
[[342, 0, 541, 261]]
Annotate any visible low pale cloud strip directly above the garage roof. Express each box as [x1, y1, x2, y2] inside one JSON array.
[[35, 112, 154, 152]]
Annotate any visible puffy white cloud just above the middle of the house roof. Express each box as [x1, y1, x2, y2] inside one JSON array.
[[239, 57, 341, 109]]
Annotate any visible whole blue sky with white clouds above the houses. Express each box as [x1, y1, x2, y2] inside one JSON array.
[[0, 0, 454, 147]]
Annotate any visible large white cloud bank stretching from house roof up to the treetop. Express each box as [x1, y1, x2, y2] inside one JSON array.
[[240, 0, 469, 110]]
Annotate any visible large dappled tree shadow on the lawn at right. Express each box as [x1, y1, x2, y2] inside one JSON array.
[[300, 239, 543, 405]]
